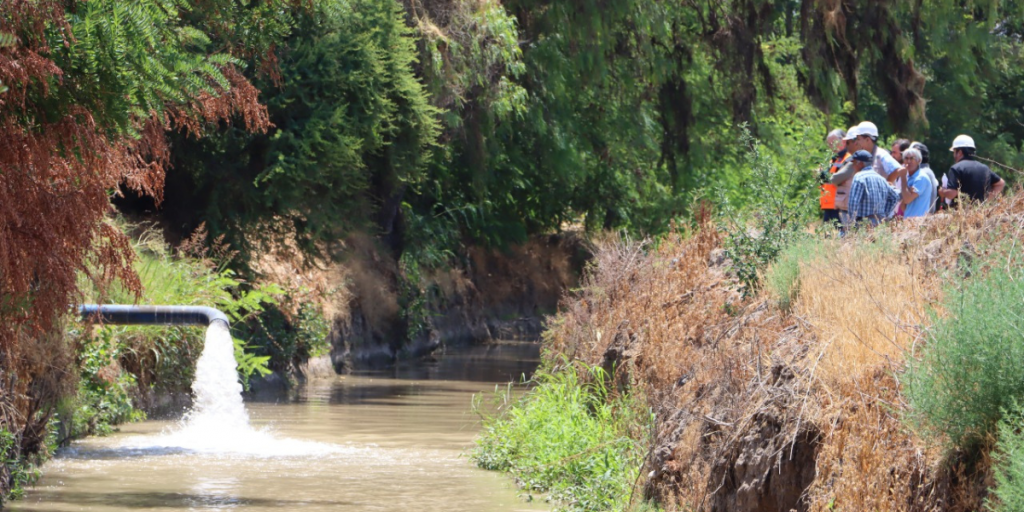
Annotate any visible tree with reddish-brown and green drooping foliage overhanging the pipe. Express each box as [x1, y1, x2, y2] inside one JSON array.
[[0, 0, 280, 475]]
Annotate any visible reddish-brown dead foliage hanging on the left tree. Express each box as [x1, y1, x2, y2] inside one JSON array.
[[0, 0, 268, 479]]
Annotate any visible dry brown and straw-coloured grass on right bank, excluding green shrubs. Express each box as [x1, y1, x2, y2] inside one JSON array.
[[547, 189, 1024, 512]]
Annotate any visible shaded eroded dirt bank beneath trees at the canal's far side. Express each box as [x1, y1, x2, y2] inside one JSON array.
[[253, 234, 589, 376]]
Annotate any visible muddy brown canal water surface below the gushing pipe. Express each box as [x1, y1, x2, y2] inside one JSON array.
[[10, 344, 542, 512]]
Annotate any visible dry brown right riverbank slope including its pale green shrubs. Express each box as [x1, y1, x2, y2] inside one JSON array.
[[485, 190, 1024, 511]]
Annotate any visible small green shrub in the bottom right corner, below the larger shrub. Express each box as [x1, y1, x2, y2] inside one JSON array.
[[986, 404, 1024, 512]]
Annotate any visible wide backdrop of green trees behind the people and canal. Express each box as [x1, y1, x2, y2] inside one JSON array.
[[151, 0, 1024, 272]]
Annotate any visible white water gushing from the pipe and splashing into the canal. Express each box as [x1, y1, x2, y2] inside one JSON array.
[[117, 322, 337, 457]]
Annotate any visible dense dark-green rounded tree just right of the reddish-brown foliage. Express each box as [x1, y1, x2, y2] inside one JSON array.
[[168, 0, 438, 254]]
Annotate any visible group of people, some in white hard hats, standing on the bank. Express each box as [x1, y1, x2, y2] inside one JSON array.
[[820, 121, 1006, 228]]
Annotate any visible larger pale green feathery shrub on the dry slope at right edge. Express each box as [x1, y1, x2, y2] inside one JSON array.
[[904, 262, 1024, 447]]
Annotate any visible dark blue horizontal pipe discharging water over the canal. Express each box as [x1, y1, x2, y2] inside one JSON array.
[[78, 304, 228, 327]]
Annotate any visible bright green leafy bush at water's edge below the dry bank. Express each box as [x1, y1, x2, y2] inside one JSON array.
[[473, 368, 651, 511]]
